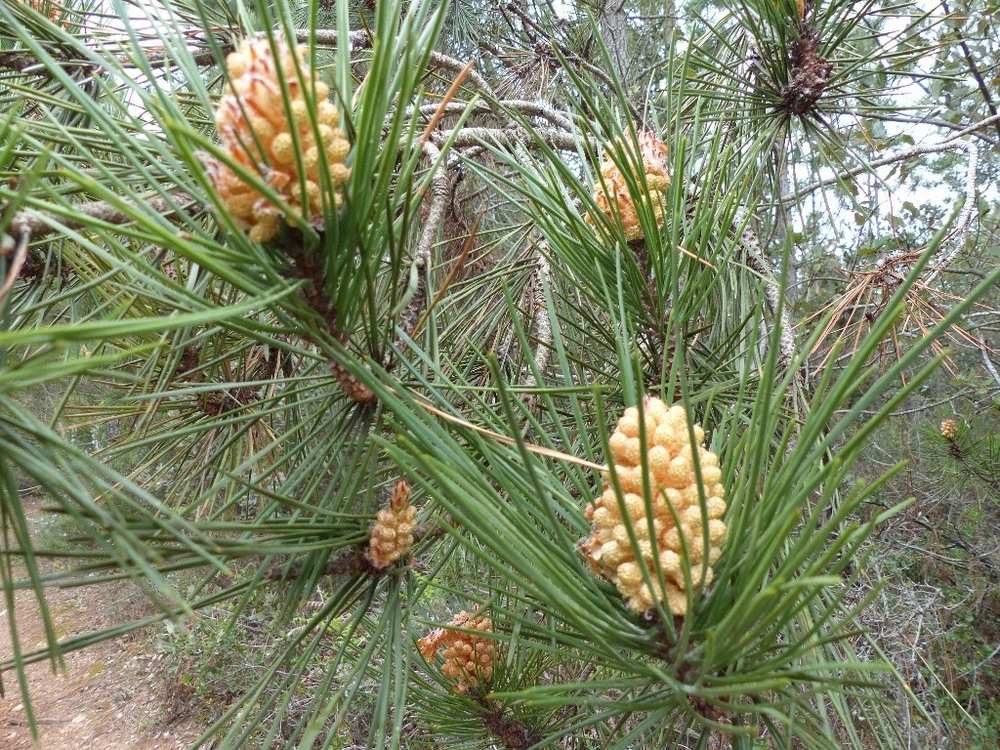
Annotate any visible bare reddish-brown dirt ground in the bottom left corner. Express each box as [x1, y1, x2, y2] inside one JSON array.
[[0, 500, 201, 750]]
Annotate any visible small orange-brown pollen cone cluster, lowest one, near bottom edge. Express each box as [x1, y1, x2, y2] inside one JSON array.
[[417, 610, 493, 693]]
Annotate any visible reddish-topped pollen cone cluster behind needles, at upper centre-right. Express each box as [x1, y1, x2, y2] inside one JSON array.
[[586, 132, 670, 241]]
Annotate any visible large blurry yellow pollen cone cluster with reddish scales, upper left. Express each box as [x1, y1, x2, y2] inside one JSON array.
[[206, 39, 351, 242]]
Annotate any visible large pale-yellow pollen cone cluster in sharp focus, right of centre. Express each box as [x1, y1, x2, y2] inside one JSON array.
[[581, 397, 726, 615]]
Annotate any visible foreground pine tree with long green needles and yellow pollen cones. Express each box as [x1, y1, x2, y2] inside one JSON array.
[[0, 0, 1000, 748]]
